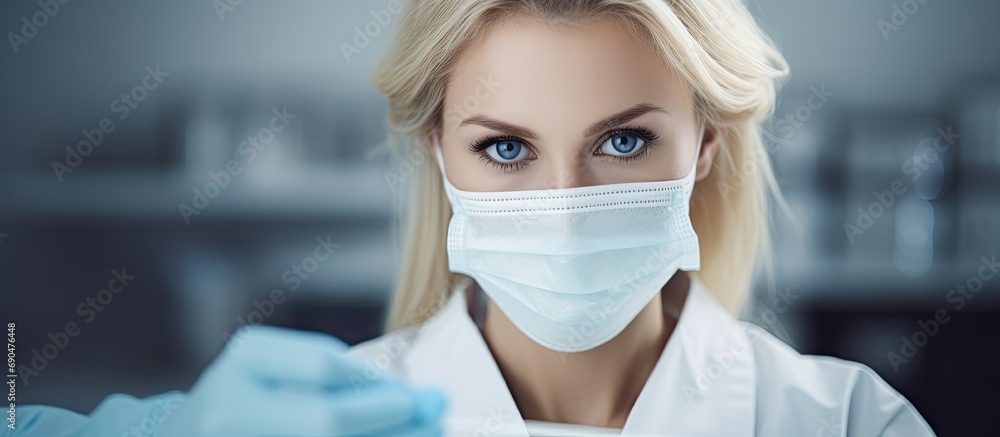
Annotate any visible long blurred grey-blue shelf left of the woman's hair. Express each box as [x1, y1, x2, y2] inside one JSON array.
[[0, 165, 393, 224]]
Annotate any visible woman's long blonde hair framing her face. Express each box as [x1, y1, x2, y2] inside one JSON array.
[[374, 0, 788, 330]]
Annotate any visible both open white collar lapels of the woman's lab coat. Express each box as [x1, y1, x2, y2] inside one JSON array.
[[405, 276, 756, 437]]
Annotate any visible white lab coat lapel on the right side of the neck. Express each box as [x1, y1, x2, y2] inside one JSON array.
[[622, 277, 756, 437]]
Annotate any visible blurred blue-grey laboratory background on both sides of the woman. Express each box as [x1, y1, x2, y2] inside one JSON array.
[[0, 0, 1000, 436]]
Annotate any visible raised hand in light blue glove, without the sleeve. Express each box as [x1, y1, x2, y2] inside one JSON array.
[[155, 326, 445, 437]]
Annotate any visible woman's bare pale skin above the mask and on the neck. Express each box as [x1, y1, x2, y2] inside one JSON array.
[[430, 19, 719, 428]]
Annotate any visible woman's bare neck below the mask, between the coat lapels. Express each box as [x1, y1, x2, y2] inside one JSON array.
[[483, 272, 689, 428]]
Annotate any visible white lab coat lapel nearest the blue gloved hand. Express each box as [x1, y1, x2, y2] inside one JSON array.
[[406, 282, 528, 437]]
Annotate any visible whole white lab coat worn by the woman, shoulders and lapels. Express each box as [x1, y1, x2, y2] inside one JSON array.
[[352, 278, 934, 437]]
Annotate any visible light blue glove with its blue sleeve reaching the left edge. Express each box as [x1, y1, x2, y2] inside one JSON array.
[[0, 326, 445, 437]]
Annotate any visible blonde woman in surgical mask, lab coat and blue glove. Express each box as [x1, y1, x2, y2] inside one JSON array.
[[7, 0, 933, 436]]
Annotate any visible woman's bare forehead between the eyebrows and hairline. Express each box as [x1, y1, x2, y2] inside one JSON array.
[[445, 19, 691, 129]]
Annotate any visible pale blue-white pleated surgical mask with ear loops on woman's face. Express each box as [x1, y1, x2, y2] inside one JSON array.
[[434, 125, 704, 352]]
